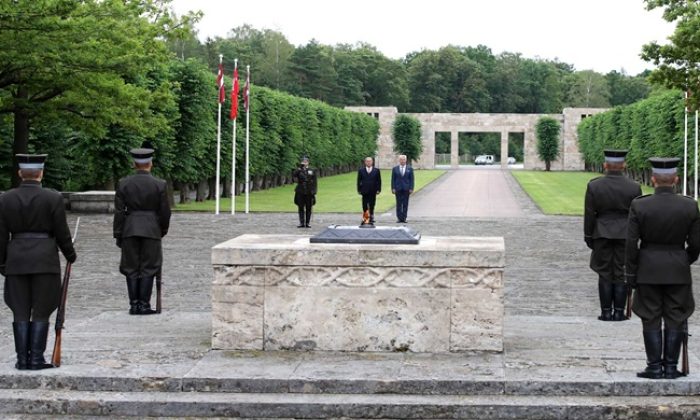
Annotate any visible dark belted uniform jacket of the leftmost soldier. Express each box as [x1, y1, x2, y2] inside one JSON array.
[[0, 181, 75, 275]]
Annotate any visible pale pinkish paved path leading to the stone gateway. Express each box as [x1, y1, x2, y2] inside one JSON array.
[[408, 167, 524, 219]]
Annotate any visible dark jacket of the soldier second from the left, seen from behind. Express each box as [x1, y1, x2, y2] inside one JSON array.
[[113, 171, 170, 239]]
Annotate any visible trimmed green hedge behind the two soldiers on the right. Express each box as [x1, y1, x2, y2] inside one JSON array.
[[578, 90, 695, 188]]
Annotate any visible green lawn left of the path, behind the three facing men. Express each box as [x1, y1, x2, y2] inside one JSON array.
[[175, 169, 445, 213]]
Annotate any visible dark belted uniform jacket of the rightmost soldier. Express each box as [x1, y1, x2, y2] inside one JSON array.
[[625, 187, 700, 284]]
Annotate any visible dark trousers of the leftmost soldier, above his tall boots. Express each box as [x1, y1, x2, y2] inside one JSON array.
[[4, 273, 61, 322]]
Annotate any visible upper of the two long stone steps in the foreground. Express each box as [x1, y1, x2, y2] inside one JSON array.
[[0, 370, 700, 397]]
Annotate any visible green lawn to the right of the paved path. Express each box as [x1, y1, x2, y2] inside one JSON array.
[[511, 171, 652, 216]]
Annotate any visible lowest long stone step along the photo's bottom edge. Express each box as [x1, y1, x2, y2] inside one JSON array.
[[0, 390, 700, 420]]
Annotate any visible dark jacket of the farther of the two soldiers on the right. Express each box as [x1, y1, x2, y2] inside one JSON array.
[[583, 172, 642, 239]]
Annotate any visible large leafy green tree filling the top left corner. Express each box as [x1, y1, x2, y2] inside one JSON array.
[[0, 0, 187, 182]]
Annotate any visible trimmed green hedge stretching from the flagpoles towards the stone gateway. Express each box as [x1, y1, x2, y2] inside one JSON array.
[[234, 86, 379, 191]]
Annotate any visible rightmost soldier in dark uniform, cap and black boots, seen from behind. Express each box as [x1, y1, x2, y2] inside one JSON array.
[[625, 158, 700, 379]]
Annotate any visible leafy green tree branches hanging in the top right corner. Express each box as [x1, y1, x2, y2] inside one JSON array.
[[642, 0, 700, 109]]
